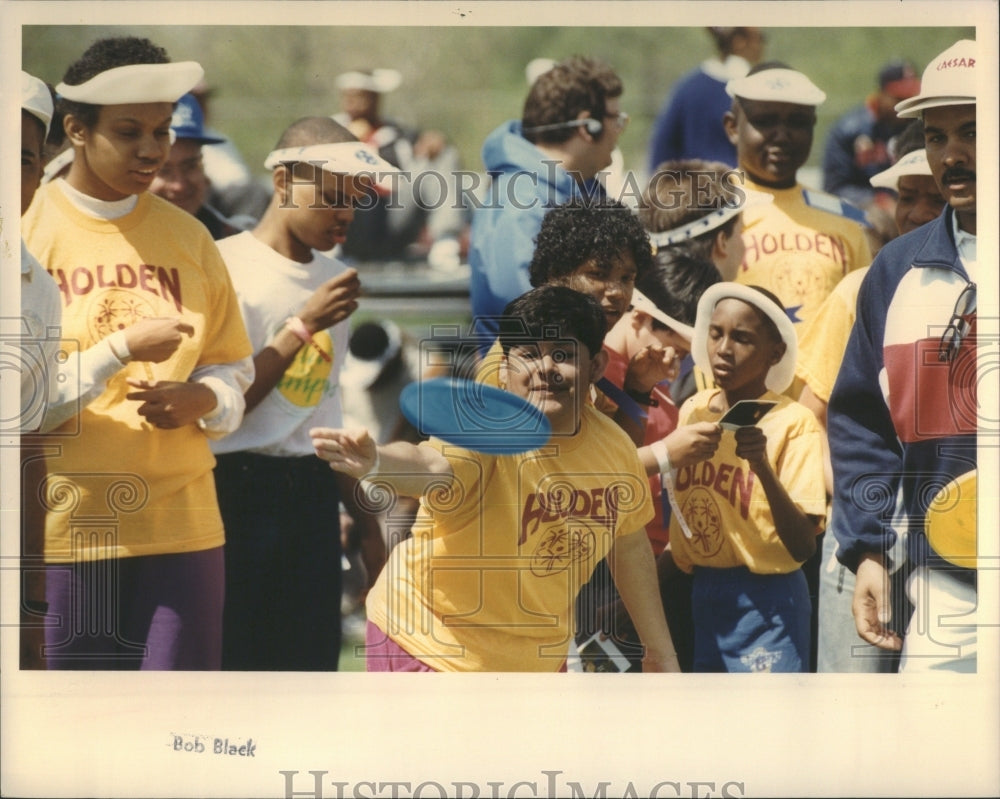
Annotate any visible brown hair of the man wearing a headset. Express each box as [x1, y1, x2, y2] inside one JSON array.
[[521, 56, 624, 144]]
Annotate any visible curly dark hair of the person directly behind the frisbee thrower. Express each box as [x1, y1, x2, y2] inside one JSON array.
[[528, 198, 653, 286]]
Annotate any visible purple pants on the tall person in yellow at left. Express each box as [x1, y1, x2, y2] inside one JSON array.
[[45, 547, 225, 671]]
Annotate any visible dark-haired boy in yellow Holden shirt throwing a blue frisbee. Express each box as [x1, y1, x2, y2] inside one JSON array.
[[312, 286, 678, 672]]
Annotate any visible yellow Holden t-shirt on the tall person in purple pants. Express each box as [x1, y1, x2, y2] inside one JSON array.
[[22, 183, 252, 562]]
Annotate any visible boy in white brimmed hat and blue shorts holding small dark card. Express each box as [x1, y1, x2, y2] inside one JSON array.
[[670, 283, 826, 672]]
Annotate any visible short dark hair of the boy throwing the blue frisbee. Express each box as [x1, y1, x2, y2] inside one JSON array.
[[499, 286, 608, 358]]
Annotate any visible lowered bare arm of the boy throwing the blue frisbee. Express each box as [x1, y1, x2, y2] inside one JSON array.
[[608, 529, 681, 671]]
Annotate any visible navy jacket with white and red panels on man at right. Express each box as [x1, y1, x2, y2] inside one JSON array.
[[828, 208, 977, 580]]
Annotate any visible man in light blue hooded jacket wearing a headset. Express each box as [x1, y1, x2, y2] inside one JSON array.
[[469, 56, 628, 348]]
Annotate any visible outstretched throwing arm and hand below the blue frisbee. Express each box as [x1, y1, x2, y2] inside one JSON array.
[[309, 427, 453, 497]]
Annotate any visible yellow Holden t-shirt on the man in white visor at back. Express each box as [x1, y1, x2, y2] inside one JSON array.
[[736, 180, 871, 335]]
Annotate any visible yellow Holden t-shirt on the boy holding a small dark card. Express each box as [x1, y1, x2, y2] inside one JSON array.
[[670, 389, 826, 574]]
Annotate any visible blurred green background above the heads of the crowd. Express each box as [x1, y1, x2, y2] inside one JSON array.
[[23, 24, 975, 184]]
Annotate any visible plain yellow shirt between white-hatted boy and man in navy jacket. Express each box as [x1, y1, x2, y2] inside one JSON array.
[[795, 266, 869, 402]]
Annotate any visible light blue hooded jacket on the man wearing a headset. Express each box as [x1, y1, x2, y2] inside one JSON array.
[[469, 120, 603, 350]]
